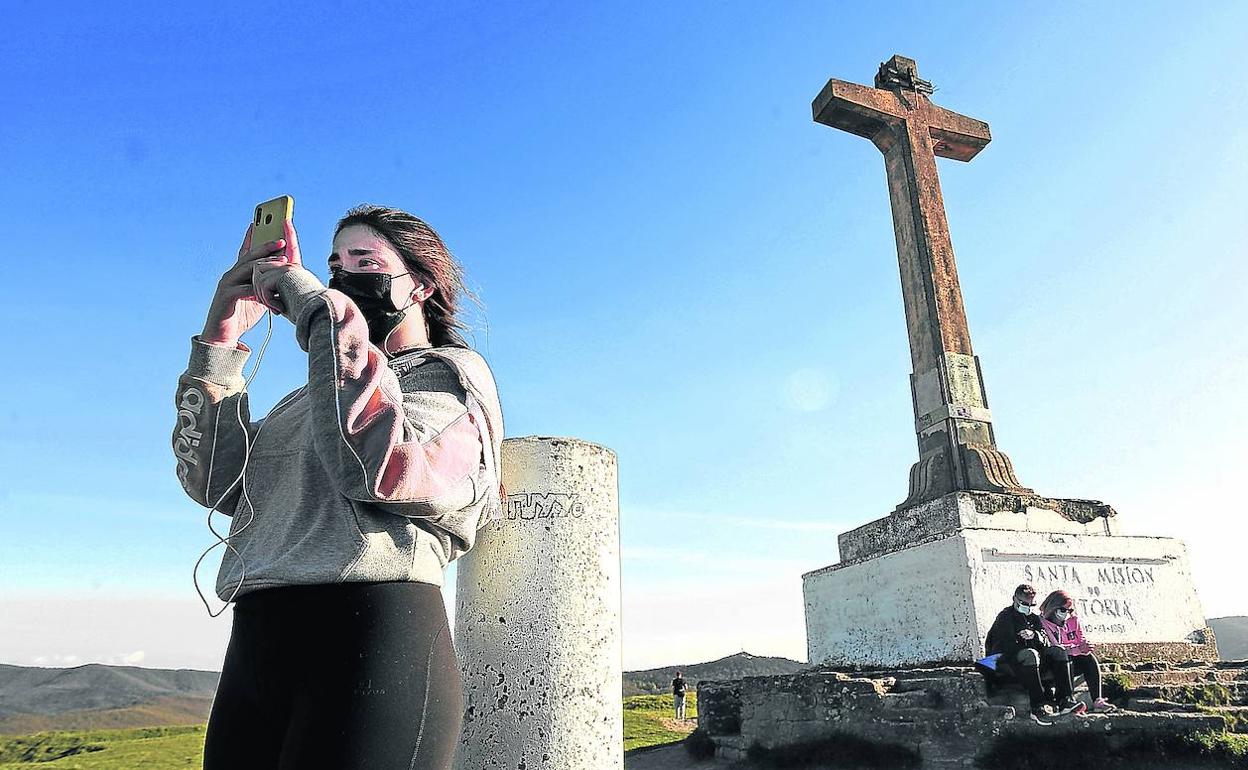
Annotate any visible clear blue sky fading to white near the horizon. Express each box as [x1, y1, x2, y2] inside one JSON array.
[[0, 2, 1248, 668]]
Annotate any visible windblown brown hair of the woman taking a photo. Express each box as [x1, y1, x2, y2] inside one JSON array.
[[333, 203, 482, 347]]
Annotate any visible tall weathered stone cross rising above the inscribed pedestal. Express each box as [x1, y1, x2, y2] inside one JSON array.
[[812, 56, 1032, 508]]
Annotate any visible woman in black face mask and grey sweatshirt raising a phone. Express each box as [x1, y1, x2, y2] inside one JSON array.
[[173, 206, 505, 770]]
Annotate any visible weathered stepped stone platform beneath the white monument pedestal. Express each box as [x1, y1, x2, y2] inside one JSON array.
[[698, 664, 1248, 769]]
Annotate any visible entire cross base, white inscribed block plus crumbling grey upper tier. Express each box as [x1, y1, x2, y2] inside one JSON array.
[[802, 492, 1218, 666]]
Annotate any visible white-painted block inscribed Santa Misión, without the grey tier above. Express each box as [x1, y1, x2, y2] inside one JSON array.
[[802, 528, 1206, 666]]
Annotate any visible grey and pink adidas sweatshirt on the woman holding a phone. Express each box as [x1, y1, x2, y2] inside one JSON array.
[[173, 268, 503, 600]]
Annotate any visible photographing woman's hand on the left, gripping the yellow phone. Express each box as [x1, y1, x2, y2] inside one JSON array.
[[200, 222, 301, 346]]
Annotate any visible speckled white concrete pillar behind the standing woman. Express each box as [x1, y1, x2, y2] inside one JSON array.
[[456, 436, 624, 770]]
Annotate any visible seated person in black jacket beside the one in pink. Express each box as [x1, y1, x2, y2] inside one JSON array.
[[983, 583, 1087, 721]]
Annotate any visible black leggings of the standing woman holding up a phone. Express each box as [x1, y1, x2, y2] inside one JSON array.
[[203, 583, 463, 770]]
